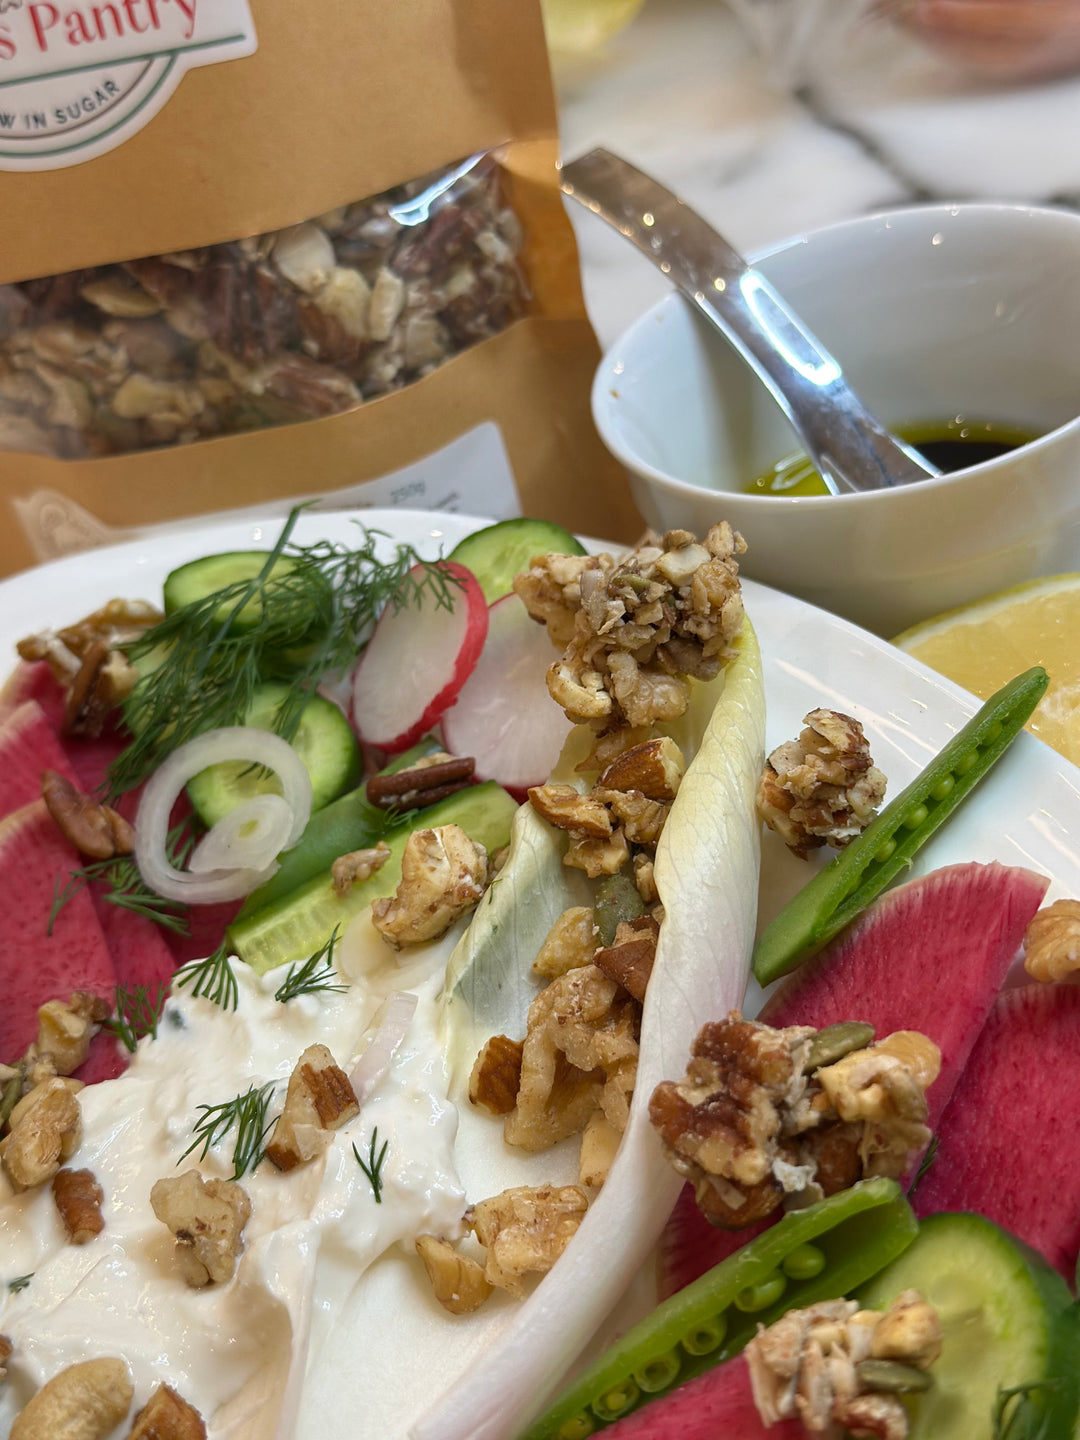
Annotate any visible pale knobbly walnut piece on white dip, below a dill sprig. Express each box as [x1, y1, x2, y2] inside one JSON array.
[[150, 1169, 251, 1289]]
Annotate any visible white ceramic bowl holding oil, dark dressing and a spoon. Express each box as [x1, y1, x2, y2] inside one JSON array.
[[593, 204, 1080, 635]]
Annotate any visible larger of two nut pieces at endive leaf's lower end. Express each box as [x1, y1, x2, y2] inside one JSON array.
[[465, 1185, 589, 1296]]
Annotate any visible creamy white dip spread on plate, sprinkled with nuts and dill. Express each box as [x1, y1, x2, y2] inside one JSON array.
[[0, 927, 465, 1440]]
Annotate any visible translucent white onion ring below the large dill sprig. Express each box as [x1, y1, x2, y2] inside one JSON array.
[[135, 726, 311, 904]]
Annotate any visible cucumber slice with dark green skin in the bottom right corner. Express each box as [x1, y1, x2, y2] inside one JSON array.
[[858, 1214, 1080, 1440]]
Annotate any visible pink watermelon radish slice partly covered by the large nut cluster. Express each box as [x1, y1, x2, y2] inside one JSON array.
[[660, 864, 1048, 1295]]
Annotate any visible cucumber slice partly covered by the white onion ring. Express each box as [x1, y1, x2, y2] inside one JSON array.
[[187, 684, 361, 825]]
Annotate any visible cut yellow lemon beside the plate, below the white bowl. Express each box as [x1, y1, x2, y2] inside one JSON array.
[[893, 575, 1080, 765]]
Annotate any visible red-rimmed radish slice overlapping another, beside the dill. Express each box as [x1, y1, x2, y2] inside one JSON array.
[[353, 560, 488, 755]]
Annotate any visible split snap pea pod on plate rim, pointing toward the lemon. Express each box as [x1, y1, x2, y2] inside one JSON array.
[[753, 665, 1050, 985]]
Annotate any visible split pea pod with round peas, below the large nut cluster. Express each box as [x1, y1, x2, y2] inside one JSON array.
[[520, 1178, 919, 1440]]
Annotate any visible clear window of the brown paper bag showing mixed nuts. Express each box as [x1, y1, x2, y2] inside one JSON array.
[[0, 157, 526, 459]]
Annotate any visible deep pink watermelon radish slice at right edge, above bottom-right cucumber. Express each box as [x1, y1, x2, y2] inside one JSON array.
[[913, 985, 1080, 1282]]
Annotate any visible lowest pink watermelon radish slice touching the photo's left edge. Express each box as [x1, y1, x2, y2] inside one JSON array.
[[0, 801, 117, 1063]]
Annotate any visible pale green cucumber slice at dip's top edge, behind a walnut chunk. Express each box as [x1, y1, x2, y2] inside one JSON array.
[[229, 780, 517, 975]]
